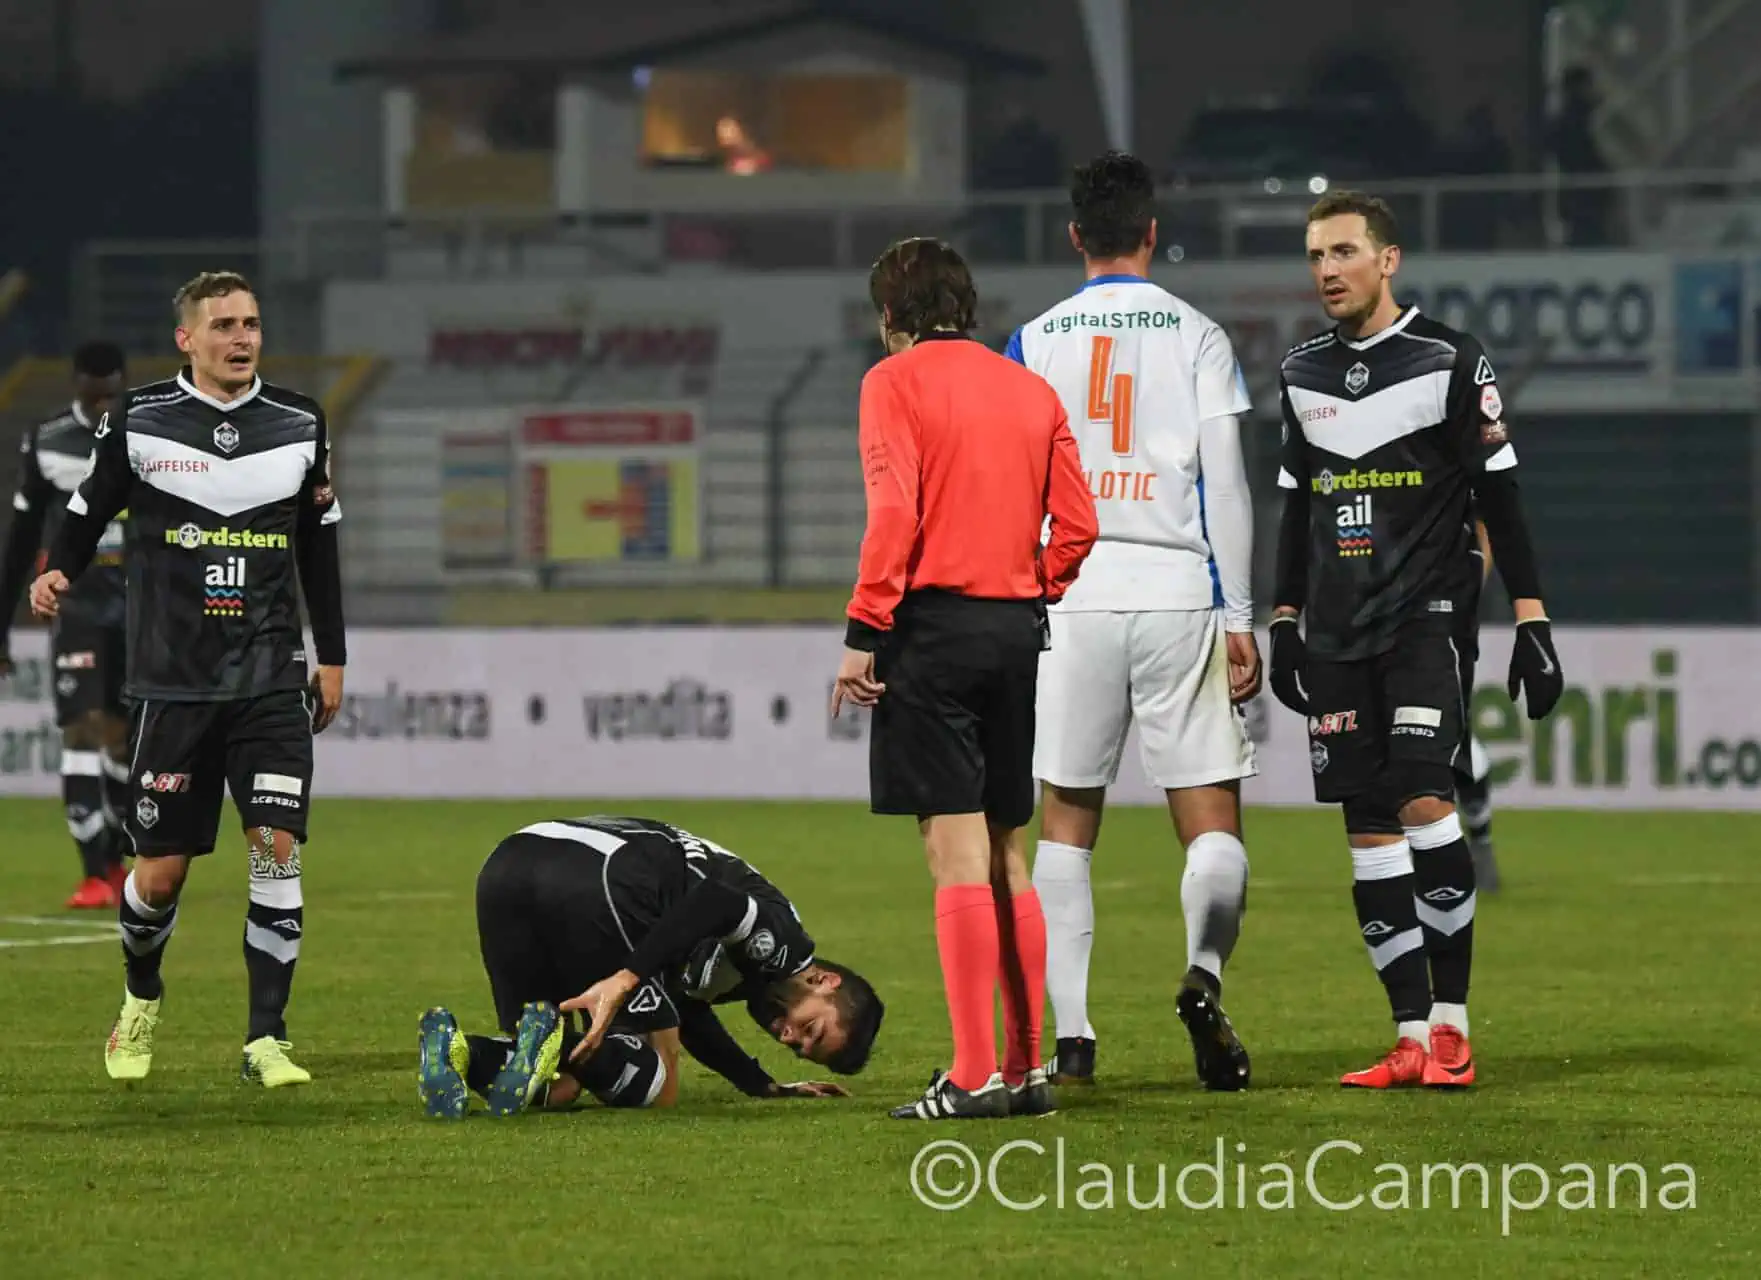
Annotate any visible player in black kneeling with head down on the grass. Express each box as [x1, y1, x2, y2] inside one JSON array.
[[417, 817, 886, 1120]]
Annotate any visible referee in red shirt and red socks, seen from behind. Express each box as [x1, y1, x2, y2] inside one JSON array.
[[833, 239, 1099, 1120]]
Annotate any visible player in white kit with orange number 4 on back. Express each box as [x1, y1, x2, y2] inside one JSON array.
[[1007, 151, 1261, 1090]]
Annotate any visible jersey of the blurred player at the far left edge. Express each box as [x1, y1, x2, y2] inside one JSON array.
[[0, 401, 129, 632]]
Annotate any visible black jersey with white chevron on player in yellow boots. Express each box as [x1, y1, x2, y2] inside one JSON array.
[[49, 368, 342, 703]]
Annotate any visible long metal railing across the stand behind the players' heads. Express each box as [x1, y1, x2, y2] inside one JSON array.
[[267, 169, 1761, 278]]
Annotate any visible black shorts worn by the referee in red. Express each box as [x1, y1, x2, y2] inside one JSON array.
[[868, 590, 1041, 828]]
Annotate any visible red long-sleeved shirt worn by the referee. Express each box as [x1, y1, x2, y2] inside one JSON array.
[[847, 333, 1101, 648]]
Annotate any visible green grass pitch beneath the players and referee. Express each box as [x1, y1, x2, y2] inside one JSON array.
[[0, 799, 1761, 1280]]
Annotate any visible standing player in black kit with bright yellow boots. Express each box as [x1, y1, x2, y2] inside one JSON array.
[[32, 271, 345, 1088]]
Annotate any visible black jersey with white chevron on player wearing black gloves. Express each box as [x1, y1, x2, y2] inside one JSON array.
[[1278, 308, 1516, 660]]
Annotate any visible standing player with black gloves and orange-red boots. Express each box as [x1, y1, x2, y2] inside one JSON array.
[[1270, 192, 1564, 1088]]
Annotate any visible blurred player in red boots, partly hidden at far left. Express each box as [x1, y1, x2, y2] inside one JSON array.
[[0, 342, 129, 910]]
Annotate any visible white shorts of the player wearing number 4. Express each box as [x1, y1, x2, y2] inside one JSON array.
[[1034, 609, 1259, 791]]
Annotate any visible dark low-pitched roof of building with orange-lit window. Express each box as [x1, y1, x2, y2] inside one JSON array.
[[336, 0, 1046, 79]]
